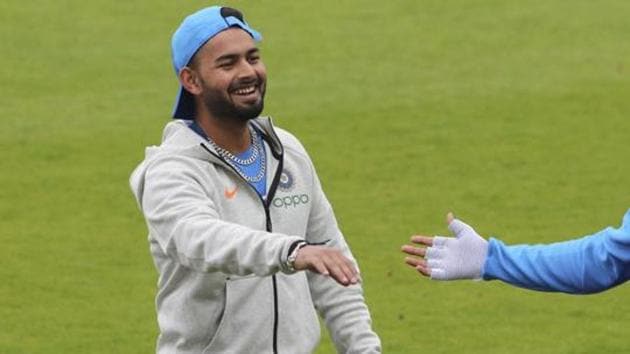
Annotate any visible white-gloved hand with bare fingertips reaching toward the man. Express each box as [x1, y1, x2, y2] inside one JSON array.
[[402, 213, 488, 280]]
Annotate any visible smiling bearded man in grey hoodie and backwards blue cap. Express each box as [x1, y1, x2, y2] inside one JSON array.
[[131, 7, 381, 353]]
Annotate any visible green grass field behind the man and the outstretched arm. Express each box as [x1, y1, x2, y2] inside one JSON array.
[[0, 0, 630, 354]]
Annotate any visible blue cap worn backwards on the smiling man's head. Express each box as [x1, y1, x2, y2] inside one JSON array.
[[171, 6, 262, 119]]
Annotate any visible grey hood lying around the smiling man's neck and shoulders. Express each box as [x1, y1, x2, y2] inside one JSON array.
[[129, 117, 282, 209]]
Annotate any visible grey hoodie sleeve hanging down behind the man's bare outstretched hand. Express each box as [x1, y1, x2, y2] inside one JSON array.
[[306, 160, 381, 353]]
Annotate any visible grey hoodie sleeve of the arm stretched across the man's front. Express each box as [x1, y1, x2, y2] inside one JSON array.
[[132, 157, 301, 276]]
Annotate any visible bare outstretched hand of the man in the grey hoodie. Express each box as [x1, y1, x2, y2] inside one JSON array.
[[293, 245, 359, 286]]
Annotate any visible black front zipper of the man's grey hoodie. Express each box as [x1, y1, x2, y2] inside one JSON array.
[[199, 140, 284, 354]]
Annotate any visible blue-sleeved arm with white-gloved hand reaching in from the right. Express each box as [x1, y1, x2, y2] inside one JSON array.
[[402, 210, 630, 294]]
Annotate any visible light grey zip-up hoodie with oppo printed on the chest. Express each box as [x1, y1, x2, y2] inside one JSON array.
[[130, 118, 381, 354]]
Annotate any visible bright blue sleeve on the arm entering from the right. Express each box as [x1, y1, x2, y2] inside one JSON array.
[[482, 210, 630, 294]]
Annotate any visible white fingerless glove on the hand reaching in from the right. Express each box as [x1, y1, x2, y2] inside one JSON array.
[[425, 219, 488, 280]]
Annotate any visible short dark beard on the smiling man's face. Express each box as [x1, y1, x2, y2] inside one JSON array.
[[202, 79, 265, 122]]
